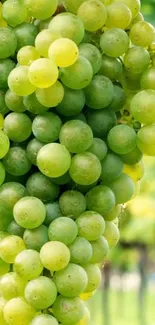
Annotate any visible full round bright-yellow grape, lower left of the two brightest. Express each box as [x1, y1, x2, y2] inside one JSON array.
[[28, 58, 58, 88]]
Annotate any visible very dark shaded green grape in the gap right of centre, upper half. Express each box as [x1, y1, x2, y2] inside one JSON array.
[[86, 109, 117, 139]]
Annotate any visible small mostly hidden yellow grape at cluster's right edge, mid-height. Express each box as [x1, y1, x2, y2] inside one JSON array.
[[124, 160, 145, 182]]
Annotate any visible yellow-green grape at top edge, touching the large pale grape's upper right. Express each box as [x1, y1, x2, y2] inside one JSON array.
[[77, 0, 107, 32]]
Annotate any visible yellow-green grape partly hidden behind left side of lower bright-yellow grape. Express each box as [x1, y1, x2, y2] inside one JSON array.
[[8, 66, 36, 96]]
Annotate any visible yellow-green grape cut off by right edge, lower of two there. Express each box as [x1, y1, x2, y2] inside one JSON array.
[[137, 124, 155, 156]]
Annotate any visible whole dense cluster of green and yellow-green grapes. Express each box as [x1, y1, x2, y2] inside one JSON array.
[[0, 0, 155, 325]]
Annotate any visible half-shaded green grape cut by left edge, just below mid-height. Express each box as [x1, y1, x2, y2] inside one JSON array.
[[0, 182, 27, 209]]
